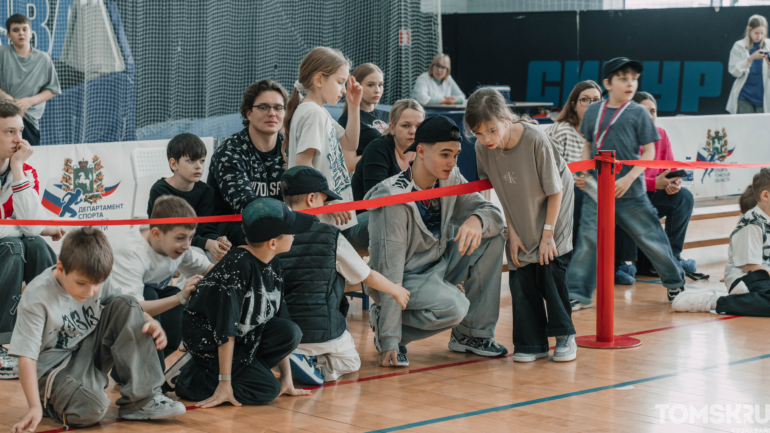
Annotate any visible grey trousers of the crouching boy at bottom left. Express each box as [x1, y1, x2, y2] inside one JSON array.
[[38, 295, 164, 427]]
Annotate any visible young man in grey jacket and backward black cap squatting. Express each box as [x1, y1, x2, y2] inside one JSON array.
[[365, 116, 508, 366]]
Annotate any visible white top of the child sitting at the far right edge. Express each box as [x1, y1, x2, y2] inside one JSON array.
[[725, 206, 770, 290]]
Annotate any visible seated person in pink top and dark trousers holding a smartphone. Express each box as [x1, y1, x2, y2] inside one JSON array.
[[615, 92, 696, 285]]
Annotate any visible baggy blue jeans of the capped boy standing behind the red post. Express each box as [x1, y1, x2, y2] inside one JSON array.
[[567, 194, 684, 304]]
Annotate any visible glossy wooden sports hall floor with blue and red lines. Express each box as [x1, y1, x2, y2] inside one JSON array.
[[0, 211, 770, 433]]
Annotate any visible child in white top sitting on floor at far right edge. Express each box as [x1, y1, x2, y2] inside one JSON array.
[[673, 167, 770, 317]]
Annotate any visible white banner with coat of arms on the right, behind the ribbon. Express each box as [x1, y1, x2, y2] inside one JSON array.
[[658, 114, 770, 198]]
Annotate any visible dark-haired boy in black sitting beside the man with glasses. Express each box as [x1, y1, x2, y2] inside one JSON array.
[[147, 133, 231, 263]]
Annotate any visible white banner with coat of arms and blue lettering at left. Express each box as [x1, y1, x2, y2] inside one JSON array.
[[27, 138, 214, 253]]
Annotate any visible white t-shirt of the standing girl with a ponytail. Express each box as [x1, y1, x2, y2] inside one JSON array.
[[286, 102, 358, 230]]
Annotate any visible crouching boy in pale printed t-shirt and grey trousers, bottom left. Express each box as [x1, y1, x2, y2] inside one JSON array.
[[9, 227, 185, 433]]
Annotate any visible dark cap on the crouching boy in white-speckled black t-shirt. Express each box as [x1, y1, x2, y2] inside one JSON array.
[[242, 198, 316, 243]]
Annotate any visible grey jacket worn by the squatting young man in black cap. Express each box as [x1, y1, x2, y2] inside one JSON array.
[[365, 167, 503, 350]]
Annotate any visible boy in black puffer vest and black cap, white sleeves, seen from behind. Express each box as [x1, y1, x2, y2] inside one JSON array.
[[279, 166, 409, 385]]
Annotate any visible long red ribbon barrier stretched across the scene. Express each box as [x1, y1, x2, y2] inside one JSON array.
[[0, 155, 770, 226]]
